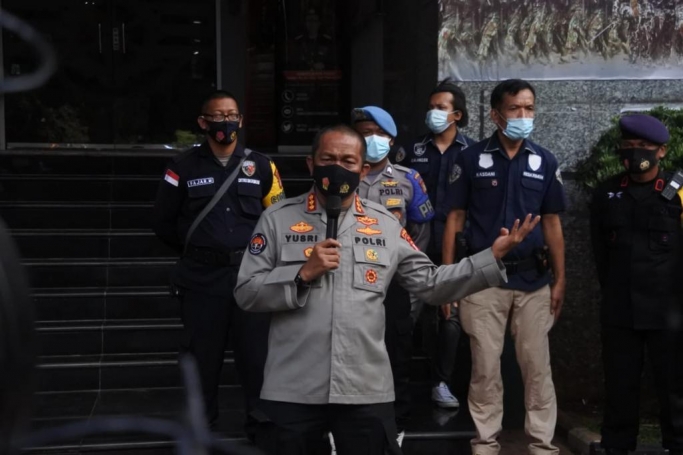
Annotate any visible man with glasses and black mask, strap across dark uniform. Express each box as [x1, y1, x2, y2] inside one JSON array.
[[153, 91, 284, 437]]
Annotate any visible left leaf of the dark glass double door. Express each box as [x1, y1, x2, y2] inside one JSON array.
[[2, 0, 113, 148]]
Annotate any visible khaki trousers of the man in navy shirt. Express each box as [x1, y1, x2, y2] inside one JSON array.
[[460, 286, 559, 455]]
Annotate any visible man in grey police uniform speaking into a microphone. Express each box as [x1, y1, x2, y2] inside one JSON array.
[[235, 125, 539, 455]]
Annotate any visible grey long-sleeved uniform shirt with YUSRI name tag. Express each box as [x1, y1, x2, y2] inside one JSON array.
[[235, 192, 506, 404]]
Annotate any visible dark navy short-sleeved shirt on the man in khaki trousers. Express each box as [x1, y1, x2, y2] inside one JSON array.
[[446, 133, 566, 291]]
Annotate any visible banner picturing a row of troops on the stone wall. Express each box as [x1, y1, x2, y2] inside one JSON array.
[[439, 0, 683, 81]]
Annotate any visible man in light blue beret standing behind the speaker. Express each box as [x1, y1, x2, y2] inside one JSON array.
[[351, 106, 434, 446]]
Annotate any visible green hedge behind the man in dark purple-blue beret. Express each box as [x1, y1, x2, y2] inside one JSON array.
[[576, 106, 683, 190]]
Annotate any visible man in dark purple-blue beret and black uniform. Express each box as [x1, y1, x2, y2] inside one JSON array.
[[591, 114, 683, 455]]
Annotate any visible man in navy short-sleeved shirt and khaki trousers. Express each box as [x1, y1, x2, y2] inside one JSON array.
[[443, 79, 565, 455]]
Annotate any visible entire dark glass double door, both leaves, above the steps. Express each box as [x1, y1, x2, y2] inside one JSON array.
[[3, 0, 216, 149]]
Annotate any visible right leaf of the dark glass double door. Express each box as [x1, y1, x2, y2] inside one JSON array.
[[112, 0, 216, 148]]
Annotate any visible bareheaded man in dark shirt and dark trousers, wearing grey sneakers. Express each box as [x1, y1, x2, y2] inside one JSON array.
[[395, 80, 475, 408]]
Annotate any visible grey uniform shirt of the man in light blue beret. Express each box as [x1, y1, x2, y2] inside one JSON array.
[[358, 163, 434, 251]]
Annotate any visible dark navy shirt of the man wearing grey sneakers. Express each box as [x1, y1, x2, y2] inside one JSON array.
[[395, 131, 475, 259]]
